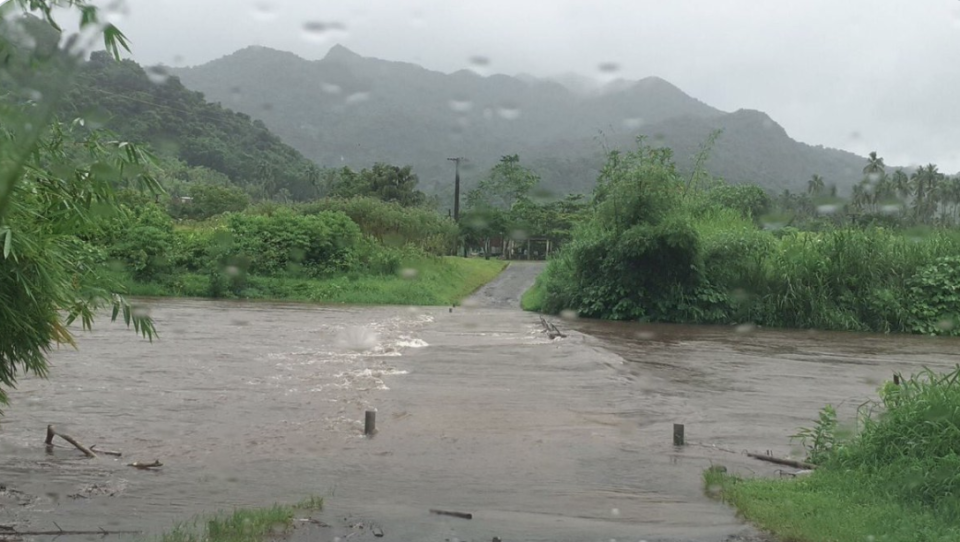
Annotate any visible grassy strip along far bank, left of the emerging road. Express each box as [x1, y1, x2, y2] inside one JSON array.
[[126, 256, 506, 305]]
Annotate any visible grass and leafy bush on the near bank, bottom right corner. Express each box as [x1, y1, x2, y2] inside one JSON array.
[[705, 367, 960, 542]]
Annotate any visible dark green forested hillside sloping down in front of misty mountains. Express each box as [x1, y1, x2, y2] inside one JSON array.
[[61, 52, 320, 199]]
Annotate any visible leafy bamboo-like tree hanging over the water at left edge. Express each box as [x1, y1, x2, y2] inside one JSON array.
[[0, 0, 159, 404]]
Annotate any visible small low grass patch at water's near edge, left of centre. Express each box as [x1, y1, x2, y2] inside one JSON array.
[[159, 497, 323, 542]]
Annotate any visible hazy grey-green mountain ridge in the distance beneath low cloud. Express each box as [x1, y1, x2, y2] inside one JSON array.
[[170, 44, 865, 199]]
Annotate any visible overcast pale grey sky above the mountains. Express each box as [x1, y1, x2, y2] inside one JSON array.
[[103, 0, 960, 172]]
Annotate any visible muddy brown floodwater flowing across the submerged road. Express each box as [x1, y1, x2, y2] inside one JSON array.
[[0, 265, 960, 541]]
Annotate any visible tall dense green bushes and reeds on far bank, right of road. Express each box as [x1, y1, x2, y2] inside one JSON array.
[[528, 137, 960, 335]]
